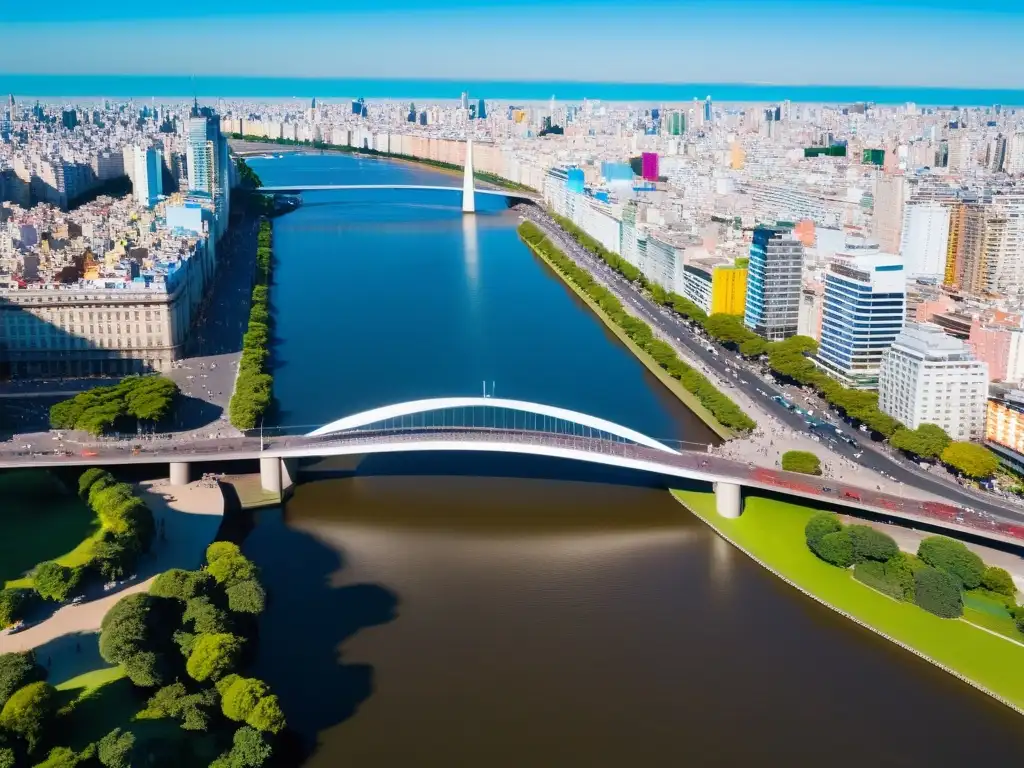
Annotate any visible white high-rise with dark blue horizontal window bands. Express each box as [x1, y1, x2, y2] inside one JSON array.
[[815, 248, 906, 389]]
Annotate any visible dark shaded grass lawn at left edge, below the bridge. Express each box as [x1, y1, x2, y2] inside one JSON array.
[[0, 471, 99, 587]]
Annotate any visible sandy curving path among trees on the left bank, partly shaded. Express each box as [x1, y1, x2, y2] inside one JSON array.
[[0, 480, 224, 684]]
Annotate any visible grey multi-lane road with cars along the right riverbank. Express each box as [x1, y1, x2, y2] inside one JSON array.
[[516, 205, 1024, 520]]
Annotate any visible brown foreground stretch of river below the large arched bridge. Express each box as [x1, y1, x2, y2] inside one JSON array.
[[245, 476, 1024, 768]]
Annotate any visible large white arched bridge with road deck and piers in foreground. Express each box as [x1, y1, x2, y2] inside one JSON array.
[[8, 397, 1024, 546]]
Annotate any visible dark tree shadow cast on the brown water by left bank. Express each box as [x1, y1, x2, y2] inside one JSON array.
[[245, 511, 398, 749]]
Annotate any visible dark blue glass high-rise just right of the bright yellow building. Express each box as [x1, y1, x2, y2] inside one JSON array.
[[743, 226, 804, 341]]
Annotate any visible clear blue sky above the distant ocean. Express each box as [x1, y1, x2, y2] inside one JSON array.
[[0, 0, 1024, 88]]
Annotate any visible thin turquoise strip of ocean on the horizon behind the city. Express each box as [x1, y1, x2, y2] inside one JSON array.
[[0, 73, 1024, 106]]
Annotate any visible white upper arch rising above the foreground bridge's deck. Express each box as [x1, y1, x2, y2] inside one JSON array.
[[307, 397, 679, 454]]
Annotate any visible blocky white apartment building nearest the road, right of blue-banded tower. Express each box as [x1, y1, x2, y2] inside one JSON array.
[[879, 323, 988, 440]]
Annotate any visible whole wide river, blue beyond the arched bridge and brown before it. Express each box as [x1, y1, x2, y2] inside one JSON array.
[[239, 156, 1024, 768]]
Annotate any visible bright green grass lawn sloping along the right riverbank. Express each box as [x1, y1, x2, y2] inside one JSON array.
[[672, 490, 1024, 708]]
